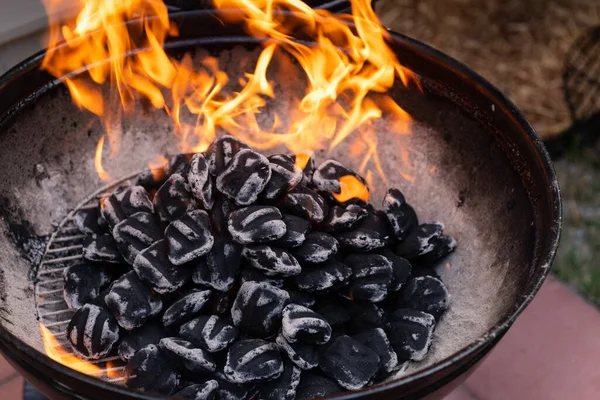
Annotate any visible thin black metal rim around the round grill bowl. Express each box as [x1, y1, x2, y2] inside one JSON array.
[[0, 10, 562, 400]]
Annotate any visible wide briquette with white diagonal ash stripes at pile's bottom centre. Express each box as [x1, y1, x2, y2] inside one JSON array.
[[223, 339, 283, 383]]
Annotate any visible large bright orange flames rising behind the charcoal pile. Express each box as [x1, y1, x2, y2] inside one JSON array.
[[42, 0, 419, 179]]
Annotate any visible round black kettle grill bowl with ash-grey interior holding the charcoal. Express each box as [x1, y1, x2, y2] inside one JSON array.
[[0, 10, 561, 400]]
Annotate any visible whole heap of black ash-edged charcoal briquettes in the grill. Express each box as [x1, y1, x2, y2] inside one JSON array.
[[64, 137, 456, 400]]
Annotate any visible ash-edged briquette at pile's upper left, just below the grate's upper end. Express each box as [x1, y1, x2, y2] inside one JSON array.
[[100, 186, 154, 227]]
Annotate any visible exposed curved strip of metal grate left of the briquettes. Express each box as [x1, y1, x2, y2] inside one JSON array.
[[34, 173, 138, 384]]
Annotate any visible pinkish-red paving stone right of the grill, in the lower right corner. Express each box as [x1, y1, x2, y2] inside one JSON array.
[[466, 277, 600, 400]]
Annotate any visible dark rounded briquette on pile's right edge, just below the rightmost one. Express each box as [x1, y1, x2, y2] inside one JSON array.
[[402, 276, 450, 319]]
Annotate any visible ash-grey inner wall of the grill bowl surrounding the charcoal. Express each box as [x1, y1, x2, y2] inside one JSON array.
[[0, 45, 535, 376]]
